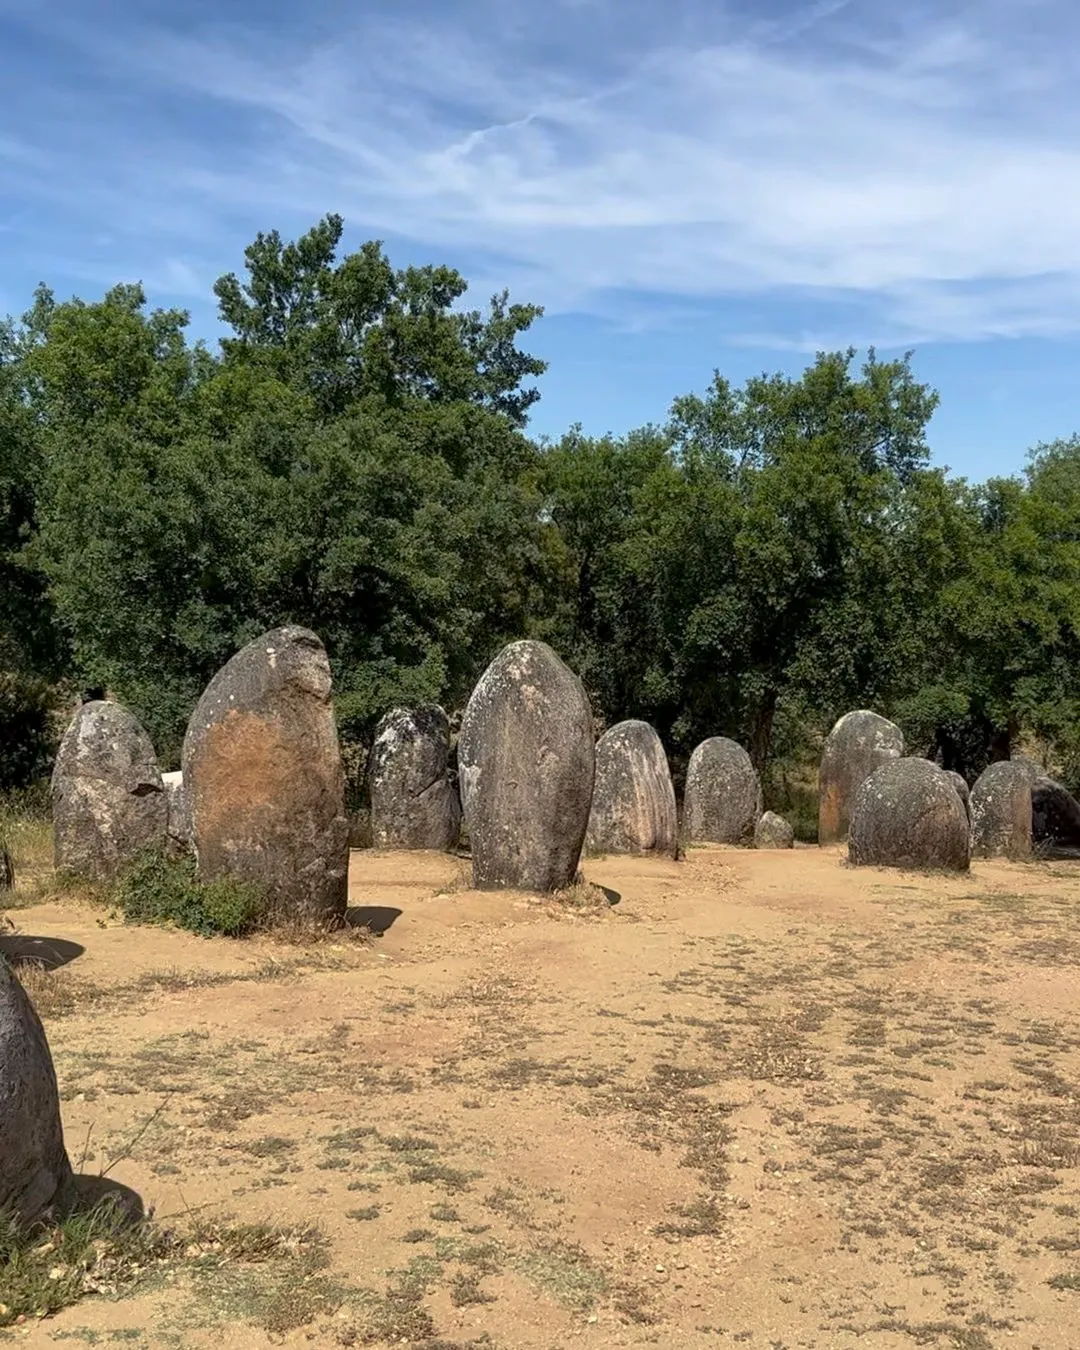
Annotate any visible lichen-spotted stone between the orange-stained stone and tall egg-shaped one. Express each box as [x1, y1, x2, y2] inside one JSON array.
[[367, 706, 462, 852]]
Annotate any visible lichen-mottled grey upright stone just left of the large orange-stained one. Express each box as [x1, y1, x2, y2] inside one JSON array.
[[53, 699, 167, 880]]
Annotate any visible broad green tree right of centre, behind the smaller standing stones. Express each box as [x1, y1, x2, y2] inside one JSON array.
[[548, 351, 937, 767]]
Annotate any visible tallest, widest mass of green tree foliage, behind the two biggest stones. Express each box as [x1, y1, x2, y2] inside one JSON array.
[[26, 221, 549, 759]]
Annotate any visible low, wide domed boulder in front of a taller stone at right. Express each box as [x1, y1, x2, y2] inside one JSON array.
[[848, 759, 971, 872]]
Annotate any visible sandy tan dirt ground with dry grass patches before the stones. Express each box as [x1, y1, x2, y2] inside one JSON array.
[[8, 848, 1080, 1350]]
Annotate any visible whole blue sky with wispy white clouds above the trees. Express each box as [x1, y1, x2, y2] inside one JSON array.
[[0, 0, 1080, 478]]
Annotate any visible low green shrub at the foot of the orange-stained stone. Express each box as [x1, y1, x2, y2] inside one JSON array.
[[112, 855, 267, 937]]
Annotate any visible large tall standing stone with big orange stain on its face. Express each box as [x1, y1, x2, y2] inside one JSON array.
[[182, 626, 348, 922]]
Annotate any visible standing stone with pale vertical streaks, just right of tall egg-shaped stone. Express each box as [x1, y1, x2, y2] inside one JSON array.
[[585, 721, 669, 857]]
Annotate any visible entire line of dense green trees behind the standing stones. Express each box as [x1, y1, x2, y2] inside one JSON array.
[[0, 216, 1080, 786]]
